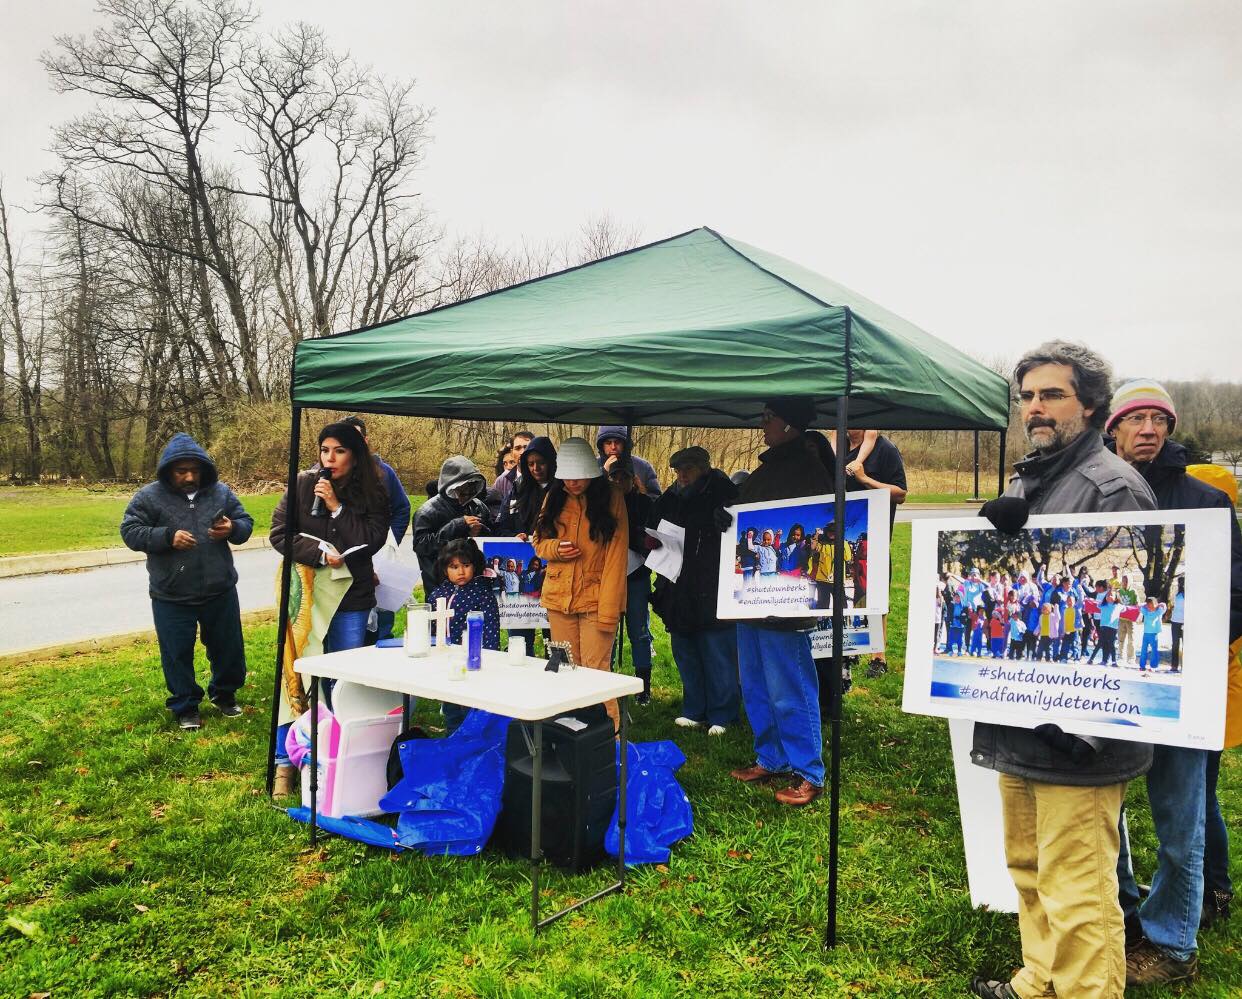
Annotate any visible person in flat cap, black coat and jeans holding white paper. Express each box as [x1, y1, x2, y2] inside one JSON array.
[[651, 447, 738, 736]]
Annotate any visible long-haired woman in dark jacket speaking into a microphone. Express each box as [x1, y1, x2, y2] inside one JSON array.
[[268, 424, 389, 652]]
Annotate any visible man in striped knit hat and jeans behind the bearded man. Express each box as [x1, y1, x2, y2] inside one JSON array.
[[1107, 379, 1242, 985]]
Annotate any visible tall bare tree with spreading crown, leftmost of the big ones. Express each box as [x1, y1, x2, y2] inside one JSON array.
[[42, 0, 263, 396]]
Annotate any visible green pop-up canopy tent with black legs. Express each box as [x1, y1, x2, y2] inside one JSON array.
[[276, 229, 1010, 944]]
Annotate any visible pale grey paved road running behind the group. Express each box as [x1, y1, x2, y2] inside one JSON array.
[[0, 506, 976, 655]]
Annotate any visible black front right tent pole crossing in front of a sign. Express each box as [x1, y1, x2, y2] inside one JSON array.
[[823, 395, 850, 947]]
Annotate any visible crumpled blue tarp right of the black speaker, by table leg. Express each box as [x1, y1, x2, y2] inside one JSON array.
[[604, 739, 694, 867]]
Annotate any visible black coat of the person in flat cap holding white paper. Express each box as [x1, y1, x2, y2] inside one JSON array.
[[651, 468, 738, 632]]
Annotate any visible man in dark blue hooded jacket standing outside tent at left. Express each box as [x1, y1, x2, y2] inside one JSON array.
[[120, 434, 255, 731]]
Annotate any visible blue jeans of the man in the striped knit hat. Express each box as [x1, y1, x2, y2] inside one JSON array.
[[1117, 745, 1207, 960]]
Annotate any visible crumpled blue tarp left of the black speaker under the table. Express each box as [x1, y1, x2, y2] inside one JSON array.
[[380, 711, 510, 856]]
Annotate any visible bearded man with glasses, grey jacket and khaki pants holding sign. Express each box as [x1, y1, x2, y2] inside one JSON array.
[[970, 340, 1155, 999]]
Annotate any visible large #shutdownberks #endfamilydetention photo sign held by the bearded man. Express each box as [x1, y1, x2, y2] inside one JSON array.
[[903, 509, 1230, 749]]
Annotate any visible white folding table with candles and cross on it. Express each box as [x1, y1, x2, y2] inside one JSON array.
[[293, 646, 642, 932]]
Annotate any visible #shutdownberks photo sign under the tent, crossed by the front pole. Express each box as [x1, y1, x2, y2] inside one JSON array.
[[717, 490, 889, 619]]
